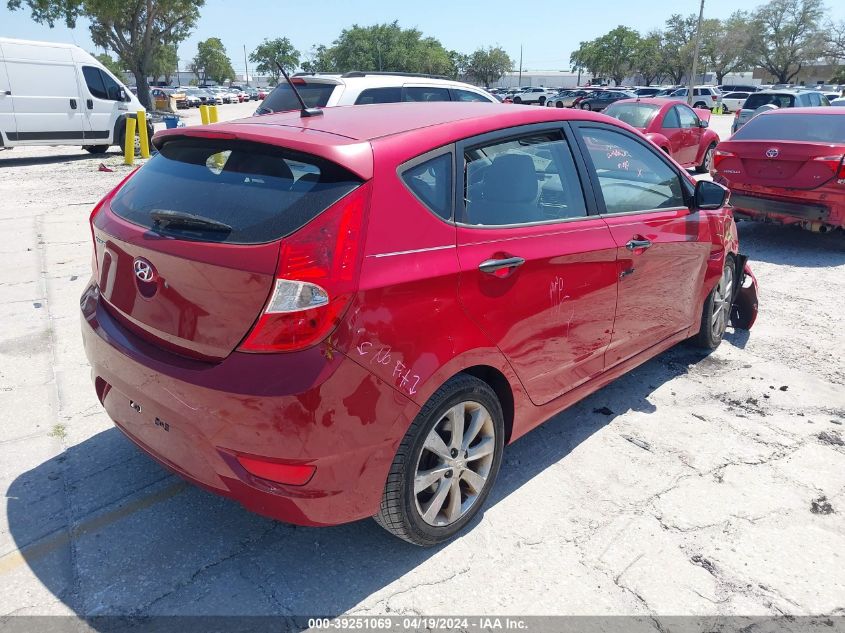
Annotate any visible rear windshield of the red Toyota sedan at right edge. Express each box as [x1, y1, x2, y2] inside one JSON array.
[[732, 113, 845, 144]]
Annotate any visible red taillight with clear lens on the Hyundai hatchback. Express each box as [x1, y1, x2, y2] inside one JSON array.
[[240, 184, 370, 352]]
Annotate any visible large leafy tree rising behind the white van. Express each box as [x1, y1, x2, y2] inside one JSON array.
[[7, 0, 205, 107]]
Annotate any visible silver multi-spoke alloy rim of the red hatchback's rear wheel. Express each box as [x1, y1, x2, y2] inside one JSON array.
[[414, 401, 496, 527]]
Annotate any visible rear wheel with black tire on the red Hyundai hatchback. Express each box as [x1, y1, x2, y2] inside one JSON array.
[[373, 374, 505, 547]]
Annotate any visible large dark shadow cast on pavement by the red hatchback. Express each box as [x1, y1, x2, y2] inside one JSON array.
[[6, 346, 708, 616]]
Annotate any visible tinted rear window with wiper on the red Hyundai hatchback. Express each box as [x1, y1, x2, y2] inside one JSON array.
[[111, 138, 362, 244]]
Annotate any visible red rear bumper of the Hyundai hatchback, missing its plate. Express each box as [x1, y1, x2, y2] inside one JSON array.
[[81, 286, 409, 525]]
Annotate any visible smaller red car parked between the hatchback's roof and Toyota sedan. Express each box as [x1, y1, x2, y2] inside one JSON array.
[[604, 99, 719, 174]]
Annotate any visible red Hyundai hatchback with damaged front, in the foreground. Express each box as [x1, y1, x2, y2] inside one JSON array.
[[81, 103, 756, 545]]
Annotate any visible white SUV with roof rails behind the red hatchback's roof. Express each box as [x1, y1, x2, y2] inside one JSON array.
[[255, 71, 499, 114]]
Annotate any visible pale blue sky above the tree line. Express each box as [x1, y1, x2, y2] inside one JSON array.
[[0, 0, 845, 72]]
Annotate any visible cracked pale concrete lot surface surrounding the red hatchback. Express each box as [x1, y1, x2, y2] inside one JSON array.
[[0, 104, 845, 628]]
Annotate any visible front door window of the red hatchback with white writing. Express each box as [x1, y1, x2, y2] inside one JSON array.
[[582, 128, 686, 213]]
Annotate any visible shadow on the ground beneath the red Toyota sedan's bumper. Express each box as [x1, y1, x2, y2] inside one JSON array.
[[737, 221, 845, 270]]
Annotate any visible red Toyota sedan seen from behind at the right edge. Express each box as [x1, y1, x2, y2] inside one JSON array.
[[713, 107, 845, 231]]
